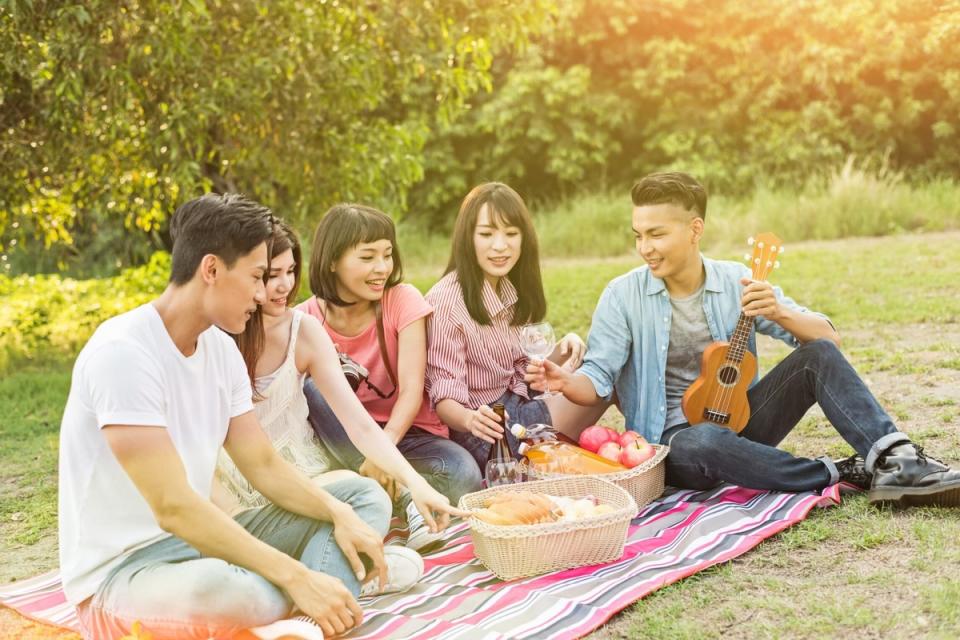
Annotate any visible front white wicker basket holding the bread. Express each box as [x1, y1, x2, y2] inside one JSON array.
[[459, 476, 637, 580]]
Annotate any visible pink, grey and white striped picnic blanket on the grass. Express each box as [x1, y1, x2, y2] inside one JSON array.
[[0, 485, 840, 640]]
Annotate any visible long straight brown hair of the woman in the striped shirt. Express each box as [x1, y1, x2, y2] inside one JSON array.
[[444, 182, 547, 326]]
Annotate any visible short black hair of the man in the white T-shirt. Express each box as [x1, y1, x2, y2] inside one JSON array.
[[170, 193, 273, 285]]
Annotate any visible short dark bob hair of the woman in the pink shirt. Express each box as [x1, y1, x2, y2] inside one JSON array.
[[310, 203, 403, 307]]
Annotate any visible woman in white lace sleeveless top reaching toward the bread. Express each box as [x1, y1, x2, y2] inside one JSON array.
[[214, 221, 459, 530]]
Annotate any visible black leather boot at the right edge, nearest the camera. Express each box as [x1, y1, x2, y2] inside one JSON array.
[[867, 442, 960, 507]]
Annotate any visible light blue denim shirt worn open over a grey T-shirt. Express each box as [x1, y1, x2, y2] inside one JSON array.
[[578, 258, 829, 443]]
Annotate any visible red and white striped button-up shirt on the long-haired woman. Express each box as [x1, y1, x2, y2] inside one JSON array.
[[426, 272, 528, 409]]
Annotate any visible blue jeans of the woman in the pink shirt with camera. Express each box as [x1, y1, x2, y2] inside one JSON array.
[[303, 379, 481, 505]]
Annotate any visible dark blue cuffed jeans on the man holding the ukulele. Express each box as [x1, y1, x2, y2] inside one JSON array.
[[660, 340, 907, 491]]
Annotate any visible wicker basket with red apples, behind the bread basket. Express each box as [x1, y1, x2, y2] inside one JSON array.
[[531, 425, 670, 509]]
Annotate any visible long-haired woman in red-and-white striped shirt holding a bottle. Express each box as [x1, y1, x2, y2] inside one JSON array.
[[426, 182, 606, 468]]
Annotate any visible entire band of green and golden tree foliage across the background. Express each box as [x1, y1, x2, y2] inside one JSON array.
[[0, 0, 960, 272]]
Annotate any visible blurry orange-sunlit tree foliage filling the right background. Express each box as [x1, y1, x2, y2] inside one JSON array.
[[414, 0, 960, 228]]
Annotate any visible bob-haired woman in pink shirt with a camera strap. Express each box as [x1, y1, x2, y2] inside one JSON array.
[[299, 204, 480, 504]]
